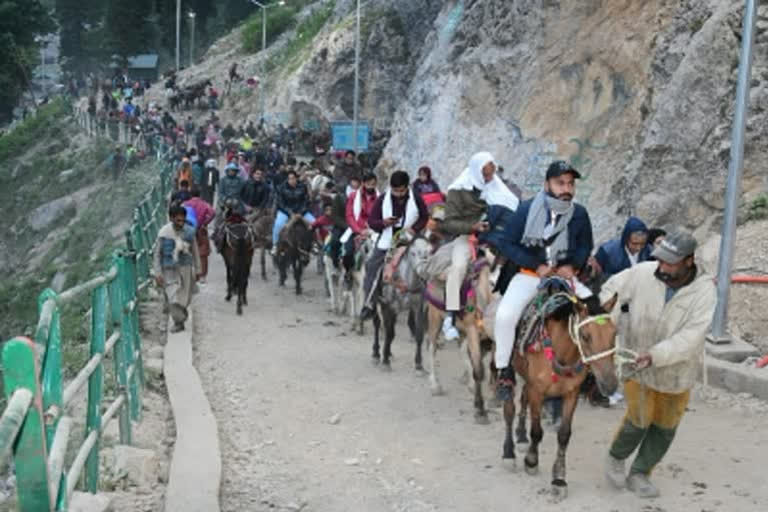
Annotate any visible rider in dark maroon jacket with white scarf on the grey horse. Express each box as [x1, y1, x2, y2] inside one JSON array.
[[360, 171, 429, 320]]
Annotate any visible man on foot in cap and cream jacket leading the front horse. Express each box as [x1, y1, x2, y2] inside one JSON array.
[[600, 230, 716, 498]]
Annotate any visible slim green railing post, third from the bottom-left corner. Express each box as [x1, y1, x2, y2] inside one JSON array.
[[85, 285, 107, 493]]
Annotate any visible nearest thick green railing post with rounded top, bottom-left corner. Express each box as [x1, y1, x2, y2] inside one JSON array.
[[3, 338, 52, 512]]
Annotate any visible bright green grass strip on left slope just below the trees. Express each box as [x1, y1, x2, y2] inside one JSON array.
[[0, 97, 72, 165]]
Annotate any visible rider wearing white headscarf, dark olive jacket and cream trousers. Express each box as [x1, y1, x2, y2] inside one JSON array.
[[440, 152, 519, 340]]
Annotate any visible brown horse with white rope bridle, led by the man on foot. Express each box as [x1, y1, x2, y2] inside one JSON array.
[[496, 277, 618, 500]]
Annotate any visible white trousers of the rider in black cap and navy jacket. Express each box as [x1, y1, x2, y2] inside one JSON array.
[[493, 272, 592, 369]]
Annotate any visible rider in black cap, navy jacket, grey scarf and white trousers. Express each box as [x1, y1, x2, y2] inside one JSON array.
[[494, 160, 593, 400]]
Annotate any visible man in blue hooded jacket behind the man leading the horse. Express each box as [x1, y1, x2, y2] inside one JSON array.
[[592, 217, 651, 280]]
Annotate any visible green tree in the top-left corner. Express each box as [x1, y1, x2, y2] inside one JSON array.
[[0, 0, 55, 119]]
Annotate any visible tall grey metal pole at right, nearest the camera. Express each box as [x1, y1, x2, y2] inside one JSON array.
[[709, 0, 758, 344]]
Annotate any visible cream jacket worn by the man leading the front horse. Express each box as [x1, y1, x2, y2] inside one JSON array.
[[600, 261, 717, 393]]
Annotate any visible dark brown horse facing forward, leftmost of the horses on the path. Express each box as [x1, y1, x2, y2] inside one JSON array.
[[221, 222, 254, 315]]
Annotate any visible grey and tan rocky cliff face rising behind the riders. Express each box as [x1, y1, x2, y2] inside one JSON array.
[[213, 0, 768, 242]]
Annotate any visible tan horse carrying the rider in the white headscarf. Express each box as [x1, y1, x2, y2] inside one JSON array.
[[424, 258, 495, 425]]
